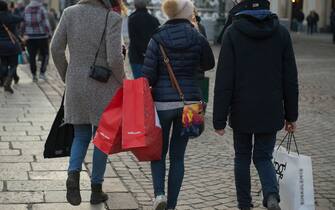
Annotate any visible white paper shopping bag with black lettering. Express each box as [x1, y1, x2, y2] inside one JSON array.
[[273, 146, 315, 210]]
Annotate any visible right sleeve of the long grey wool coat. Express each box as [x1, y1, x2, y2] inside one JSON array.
[[106, 12, 125, 83]]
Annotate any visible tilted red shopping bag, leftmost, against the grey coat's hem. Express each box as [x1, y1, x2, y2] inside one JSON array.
[[93, 88, 123, 155]]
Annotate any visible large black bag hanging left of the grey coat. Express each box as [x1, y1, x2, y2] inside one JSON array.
[[43, 96, 74, 158]]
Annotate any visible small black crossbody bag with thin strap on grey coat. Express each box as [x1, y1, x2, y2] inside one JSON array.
[[89, 11, 112, 83]]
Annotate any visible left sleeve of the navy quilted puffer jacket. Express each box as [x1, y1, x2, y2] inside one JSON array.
[[142, 39, 160, 86]]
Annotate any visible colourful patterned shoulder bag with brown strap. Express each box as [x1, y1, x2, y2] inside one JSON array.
[[159, 44, 206, 138]]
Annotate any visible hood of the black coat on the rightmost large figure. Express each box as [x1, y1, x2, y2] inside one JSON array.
[[233, 13, 279, 39]]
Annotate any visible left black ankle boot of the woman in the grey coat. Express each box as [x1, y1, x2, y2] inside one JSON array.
[[66, 171, 81, 206]]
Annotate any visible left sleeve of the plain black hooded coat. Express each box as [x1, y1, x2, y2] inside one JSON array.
[[213, 32, 235, 130]]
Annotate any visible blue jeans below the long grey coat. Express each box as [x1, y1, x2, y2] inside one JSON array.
[[68, 125, 107, 184]]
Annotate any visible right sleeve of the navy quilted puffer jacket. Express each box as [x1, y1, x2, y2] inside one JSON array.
[[200, 35, 215, 71]]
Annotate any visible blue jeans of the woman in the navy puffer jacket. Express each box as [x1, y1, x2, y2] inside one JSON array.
[[151, 109, 188, 209]]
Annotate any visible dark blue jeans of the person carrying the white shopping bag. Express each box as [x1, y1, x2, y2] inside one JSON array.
[[234, 132, 279, 208]]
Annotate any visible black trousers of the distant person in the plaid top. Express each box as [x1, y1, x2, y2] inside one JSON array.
[[27, 38, 49, 76]]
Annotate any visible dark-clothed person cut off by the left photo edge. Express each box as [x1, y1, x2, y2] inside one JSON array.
[[0, 0, 23, 93]]
